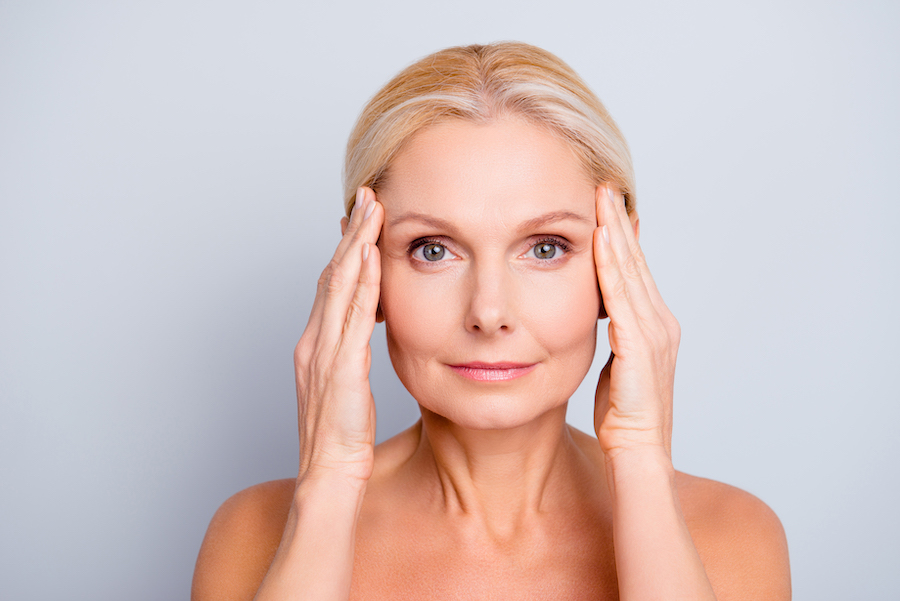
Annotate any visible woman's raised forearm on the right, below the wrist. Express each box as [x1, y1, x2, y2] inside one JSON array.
[[606, 448, 715, 601]]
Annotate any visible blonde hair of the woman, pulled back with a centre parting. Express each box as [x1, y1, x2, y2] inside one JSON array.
[[344, 42, 635, 215]]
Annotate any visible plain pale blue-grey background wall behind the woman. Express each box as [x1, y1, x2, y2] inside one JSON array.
[[0, 0, 900, 600]]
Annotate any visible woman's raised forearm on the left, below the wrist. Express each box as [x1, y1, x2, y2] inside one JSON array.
[[255, 478, 365, 601]]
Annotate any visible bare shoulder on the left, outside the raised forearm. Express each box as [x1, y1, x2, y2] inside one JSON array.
[[191, 479, 295, 601]]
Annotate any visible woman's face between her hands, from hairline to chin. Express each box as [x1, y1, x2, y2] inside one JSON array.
[[378, 118, 600, 429]]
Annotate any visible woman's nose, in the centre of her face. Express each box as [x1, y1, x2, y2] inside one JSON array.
[[466, 266, 515, 335]]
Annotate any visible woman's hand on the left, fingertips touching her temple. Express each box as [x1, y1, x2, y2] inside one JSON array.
[[294, 188, 384, 484]]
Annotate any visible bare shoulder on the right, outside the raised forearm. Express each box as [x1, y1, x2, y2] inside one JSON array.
[[676, 472, 791, 601]]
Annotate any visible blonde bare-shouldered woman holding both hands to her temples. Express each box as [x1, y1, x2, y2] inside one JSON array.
[[193, 43, 790, 601]]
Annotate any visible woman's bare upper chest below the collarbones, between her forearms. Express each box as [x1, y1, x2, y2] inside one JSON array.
[[350, 512, 618, 601]]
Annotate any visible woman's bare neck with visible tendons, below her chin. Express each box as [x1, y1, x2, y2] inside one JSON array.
[[406, 405, 596, 536]]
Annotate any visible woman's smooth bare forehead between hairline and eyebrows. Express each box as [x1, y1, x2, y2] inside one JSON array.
[[378, 118, 594, 223]]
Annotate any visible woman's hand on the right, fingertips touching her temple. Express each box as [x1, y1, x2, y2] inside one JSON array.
[[594, 186, 681, 458]]
